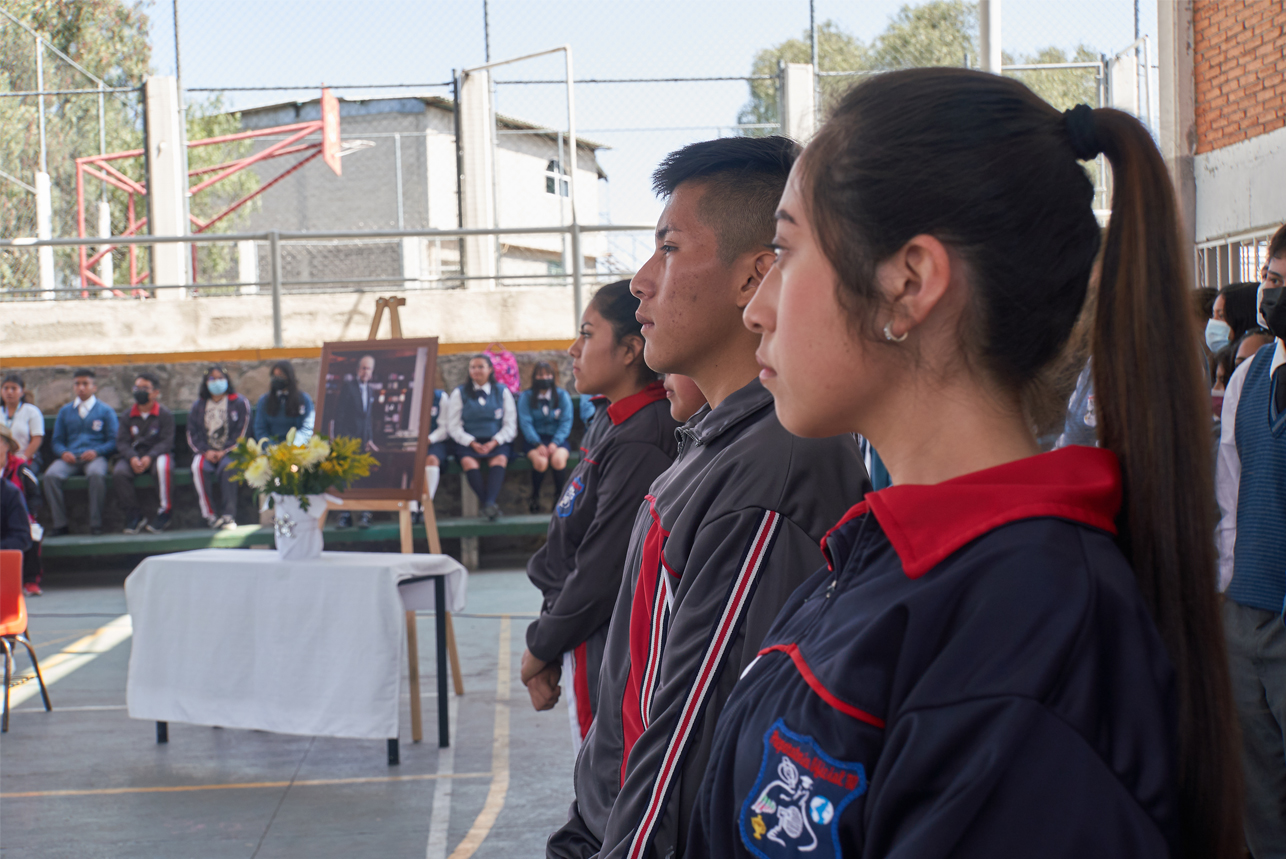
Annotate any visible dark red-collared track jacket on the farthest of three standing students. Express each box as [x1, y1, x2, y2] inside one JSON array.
[[527, 382, 679, 738]]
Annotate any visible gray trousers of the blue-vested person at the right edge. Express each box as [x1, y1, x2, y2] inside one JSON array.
[[1223, 599, 1286, 859]]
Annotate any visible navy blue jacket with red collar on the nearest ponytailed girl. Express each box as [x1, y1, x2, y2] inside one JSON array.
[[687, 448, 1178, 859]]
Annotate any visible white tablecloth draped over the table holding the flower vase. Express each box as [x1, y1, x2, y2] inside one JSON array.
[[125, 549, 468, 739]]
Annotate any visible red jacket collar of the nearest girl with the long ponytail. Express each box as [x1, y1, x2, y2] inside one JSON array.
[[822, 445, 1121, 579]]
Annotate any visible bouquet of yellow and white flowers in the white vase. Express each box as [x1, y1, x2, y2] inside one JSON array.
[[228, 430, 377, 512]]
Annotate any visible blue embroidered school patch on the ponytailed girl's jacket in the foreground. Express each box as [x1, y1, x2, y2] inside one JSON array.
[[741, 719, 867, 859]]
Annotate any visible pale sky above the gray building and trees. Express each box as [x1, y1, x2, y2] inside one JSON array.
[[140, 0, 1165, 241]]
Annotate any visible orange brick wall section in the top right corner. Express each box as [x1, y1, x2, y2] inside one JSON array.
[[1192, 0, 1286, 153]]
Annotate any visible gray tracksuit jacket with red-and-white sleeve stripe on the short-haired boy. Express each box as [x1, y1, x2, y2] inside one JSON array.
[[547, 379, 869, 859]]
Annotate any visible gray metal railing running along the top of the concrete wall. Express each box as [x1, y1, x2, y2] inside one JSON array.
[[0, 224, 655, 348]]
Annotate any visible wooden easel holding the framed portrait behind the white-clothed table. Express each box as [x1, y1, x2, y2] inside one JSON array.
[[318, 297, 464, 743]]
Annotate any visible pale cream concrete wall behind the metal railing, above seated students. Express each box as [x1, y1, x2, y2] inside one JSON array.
[[0, 285, 590, 365]]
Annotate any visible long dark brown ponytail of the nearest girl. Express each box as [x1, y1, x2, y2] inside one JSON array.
[[1091, 109, 1245, 859]]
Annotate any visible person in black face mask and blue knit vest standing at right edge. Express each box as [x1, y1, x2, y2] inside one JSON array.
[[1215, 226, 1286, 856]]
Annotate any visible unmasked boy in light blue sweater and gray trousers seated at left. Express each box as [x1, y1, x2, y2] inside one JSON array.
[[44, 368, 118, 536]]
